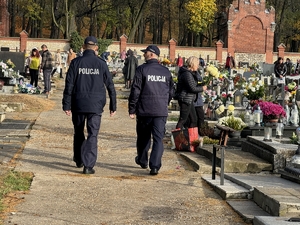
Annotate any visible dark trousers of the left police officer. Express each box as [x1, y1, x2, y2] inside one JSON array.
[[72, 112, 101, 168]]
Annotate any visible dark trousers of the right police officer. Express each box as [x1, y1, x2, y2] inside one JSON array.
[[136, 116, 167, 170]]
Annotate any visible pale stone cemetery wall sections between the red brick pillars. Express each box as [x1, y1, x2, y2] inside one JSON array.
[[0, 37, 300, 65]]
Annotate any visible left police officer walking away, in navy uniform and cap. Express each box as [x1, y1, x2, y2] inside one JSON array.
[[62, 36, 116, 174]]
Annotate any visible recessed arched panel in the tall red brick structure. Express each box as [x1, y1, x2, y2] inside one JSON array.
[[233, 16, 266, 54]]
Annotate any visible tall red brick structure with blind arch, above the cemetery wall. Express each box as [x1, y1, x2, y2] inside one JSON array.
[[228, 0, 275, 63]]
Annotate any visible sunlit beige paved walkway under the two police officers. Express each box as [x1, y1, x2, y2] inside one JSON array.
[[4, 82, 245, 225]]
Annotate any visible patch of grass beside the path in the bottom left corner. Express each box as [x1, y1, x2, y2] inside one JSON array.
[[0, 170, 33, 221]]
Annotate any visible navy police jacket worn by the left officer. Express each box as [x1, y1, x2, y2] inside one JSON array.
[[62, 50, 117, 114]]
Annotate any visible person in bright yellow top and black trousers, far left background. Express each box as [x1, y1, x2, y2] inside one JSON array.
[[26, 48, 42, 87]]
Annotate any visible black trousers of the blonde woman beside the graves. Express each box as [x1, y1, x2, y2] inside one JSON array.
[[176, 101, 197, 128]]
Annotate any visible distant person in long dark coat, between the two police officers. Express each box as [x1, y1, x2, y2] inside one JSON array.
[[123, 49, 138, 89]]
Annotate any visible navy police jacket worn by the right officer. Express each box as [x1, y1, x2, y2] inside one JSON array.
[[128, 59, 174, 117]]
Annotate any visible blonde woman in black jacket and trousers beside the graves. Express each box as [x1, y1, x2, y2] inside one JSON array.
[[176, 56, 207, 128]]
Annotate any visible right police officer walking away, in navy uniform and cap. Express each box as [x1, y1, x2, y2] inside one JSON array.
[[128, 45, 173, 175]]
